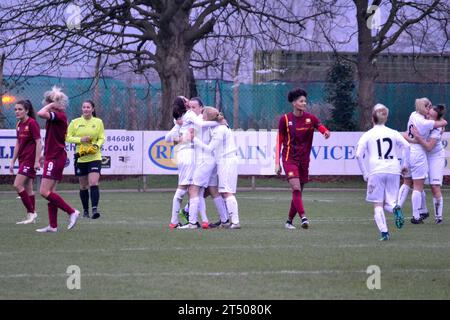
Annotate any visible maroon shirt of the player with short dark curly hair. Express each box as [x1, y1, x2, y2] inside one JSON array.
[[278, 112, 322, 162]]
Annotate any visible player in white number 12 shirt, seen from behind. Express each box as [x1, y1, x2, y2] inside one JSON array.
[[356, 104, 409, 241]]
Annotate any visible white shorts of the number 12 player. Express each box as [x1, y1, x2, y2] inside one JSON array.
[[366, 173, 400, 207]]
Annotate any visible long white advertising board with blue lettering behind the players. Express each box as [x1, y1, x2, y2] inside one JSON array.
[[0, 130, 450, 175]]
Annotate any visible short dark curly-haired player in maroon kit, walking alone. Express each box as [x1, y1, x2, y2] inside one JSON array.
[[275, 88, 330, 229]]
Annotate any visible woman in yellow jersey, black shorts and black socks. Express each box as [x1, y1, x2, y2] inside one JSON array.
[[66, 100, 105, 219]]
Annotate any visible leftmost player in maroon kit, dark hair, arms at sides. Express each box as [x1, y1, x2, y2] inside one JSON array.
[[9, 100, 42, 224]]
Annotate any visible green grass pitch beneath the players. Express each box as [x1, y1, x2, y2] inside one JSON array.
[[0, 189, 450, 300]]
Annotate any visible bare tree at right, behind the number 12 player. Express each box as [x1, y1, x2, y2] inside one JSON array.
[[315, 0, 450, 130]]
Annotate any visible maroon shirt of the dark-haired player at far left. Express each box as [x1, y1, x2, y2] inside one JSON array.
[[17, 118, 41, 166]]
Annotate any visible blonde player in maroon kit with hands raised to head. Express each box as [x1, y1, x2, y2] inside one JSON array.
[[36, 87, 80, 232]]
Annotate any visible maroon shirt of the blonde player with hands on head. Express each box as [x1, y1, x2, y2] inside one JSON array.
[[44, 111, 68, 160]]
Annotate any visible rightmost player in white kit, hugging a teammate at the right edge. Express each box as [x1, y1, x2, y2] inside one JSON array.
[[411, 105, 446, 224]]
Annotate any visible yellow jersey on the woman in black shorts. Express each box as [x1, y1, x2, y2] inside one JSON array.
[[66, 117, 105, 162]]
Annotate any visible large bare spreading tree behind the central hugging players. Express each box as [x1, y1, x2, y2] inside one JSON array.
[[0, 0, 330, 129]]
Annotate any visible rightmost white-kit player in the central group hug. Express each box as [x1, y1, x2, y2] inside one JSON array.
[[194, 108, 241, 229]]
